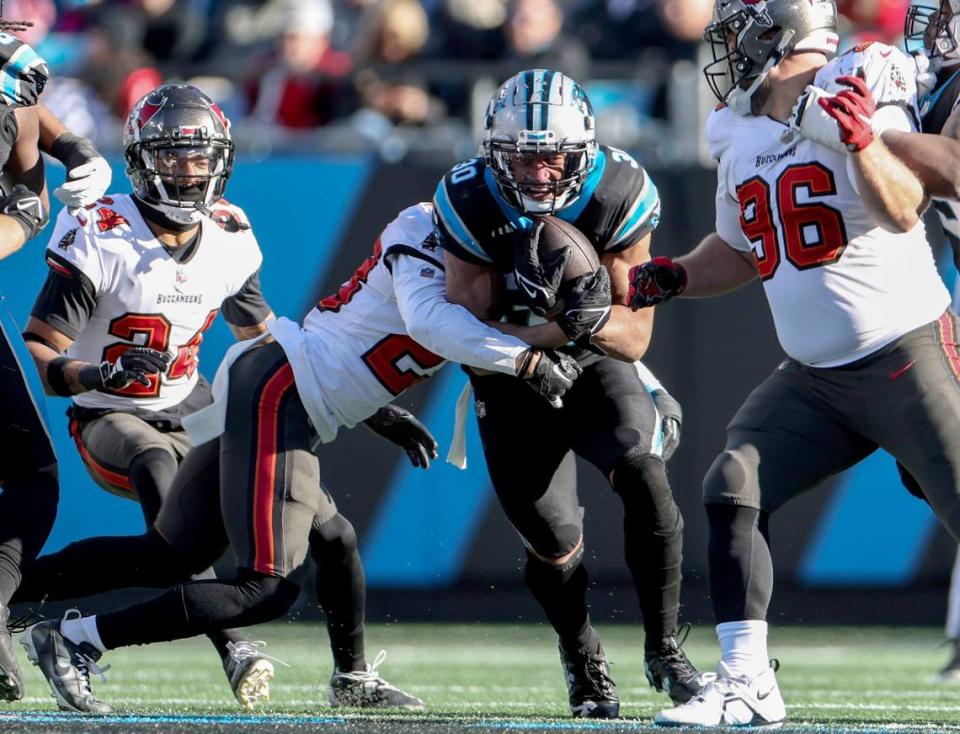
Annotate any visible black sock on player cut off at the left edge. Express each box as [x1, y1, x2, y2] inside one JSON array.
[[0, 466, 60, 605]]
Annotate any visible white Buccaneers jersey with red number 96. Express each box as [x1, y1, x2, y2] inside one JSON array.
[[707, 43, 950, 367]]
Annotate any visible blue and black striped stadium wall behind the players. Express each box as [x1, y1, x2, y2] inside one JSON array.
[[0, 155, 955, 622]]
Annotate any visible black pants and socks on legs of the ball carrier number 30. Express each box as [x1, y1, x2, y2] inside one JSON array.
[[470, 358, 683, 650]]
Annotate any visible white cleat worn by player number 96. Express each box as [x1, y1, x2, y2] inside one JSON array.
[[654, 661, 787, 729]]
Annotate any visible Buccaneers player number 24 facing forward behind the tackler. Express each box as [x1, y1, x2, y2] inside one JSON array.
[[16, 84, 419, 708]]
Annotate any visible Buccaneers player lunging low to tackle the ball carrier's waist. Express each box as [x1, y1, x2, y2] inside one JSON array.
[[16, 198, 579, 712]]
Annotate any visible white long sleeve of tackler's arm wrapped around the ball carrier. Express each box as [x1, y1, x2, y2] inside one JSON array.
[[390, 249, 529, 375]]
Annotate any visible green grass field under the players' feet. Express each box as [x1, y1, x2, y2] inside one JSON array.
[[0, 623, 960, 734]]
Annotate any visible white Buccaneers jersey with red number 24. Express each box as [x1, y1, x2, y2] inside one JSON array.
[[47, 194, 263, 410]]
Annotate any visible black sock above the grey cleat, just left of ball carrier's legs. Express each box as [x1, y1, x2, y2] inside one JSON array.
[[310, 514, 367, 671]]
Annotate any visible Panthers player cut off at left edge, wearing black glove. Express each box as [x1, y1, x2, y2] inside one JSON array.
[[0, 30, 59, 701]]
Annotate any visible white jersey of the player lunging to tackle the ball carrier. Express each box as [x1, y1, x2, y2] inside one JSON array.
[[267, 204, 527, 442]]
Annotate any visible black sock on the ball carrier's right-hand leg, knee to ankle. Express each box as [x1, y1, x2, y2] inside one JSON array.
[[613, 452, 683, 652]]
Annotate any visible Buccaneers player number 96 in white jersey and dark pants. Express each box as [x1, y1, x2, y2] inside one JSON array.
[[631, 0, 960, 727]]
